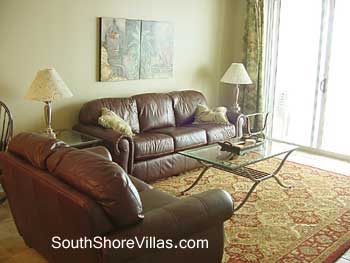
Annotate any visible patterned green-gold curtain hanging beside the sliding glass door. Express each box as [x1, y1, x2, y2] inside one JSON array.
[[239, 0, 264, 114]]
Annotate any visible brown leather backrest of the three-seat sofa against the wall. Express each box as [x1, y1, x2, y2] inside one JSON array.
[[79, 90, 207, 133]]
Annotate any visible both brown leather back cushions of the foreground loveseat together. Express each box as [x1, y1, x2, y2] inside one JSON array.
[[4, 133, 143, 227]]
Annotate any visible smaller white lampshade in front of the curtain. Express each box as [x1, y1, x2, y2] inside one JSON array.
[[221, 63, 253, 84]]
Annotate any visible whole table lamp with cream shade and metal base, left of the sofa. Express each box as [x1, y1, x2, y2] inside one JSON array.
[[25, 68, 73, 138]]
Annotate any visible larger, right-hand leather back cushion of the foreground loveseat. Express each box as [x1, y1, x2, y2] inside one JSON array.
[[48, 148, 143, 227]]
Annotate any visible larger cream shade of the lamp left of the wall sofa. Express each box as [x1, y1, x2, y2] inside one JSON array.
[[25, 68, 73, 102]]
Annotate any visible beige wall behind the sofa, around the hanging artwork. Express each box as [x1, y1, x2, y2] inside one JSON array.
[[0, 0, 244, 133]]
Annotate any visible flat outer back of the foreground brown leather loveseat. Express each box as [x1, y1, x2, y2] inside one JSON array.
[[0, 134, 115, 262]]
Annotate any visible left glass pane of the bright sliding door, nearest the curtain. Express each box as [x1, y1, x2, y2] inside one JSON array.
[[272, 0, 322, 146]]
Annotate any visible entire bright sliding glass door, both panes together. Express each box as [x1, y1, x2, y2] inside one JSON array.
[[268, 0, 350, 159]]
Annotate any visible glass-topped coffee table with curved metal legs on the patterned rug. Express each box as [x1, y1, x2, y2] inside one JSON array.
[[179, 139, 298, 212]]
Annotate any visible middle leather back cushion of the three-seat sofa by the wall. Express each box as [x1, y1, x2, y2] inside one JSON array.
[[133, 93, 175, 132]]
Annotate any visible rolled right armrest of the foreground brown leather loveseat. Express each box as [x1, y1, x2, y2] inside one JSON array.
[[103, 190, 233, 262]]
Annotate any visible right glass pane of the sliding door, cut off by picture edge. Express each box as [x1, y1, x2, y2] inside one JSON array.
[[319, 0, 350, 155]]
